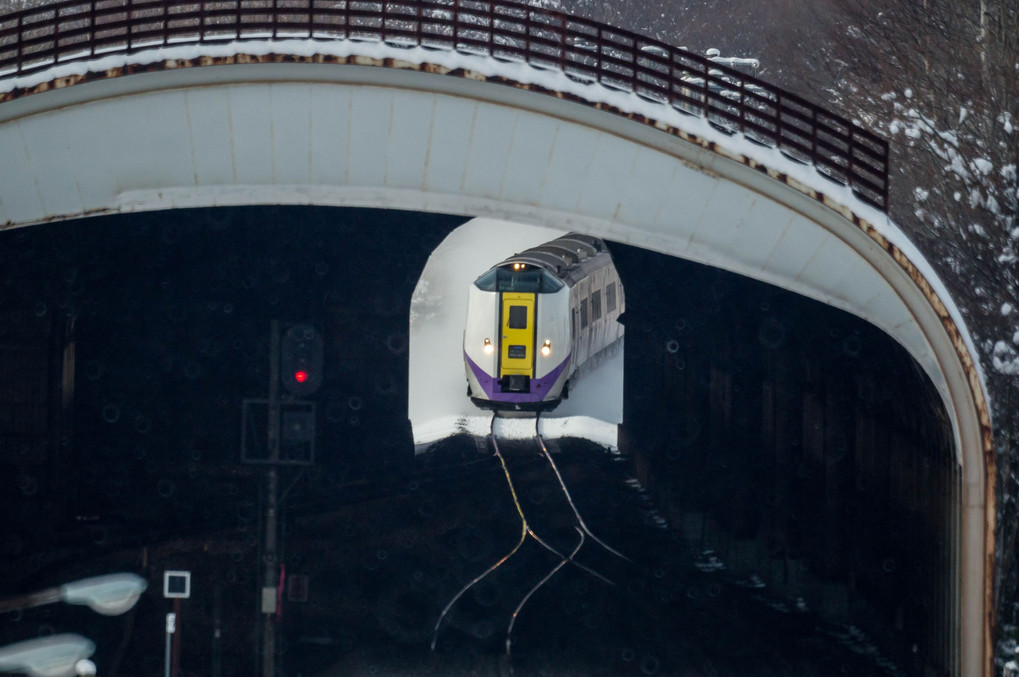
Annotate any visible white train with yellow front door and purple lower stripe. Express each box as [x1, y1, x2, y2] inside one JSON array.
[[464, 232, 626, 411]]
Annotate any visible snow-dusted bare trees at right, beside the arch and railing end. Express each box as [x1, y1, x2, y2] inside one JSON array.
[[833, 0, 1019, 376]]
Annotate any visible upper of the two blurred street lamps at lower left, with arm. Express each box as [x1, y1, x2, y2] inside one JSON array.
[[0, 574, 149, 616]]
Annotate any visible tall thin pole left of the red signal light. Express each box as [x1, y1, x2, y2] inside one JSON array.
[[262, 320, 279, 677]]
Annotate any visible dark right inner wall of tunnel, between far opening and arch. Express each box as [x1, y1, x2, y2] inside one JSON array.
[[612, 241, 959, 669]]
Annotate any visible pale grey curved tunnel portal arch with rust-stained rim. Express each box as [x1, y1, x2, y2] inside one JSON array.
[[0, 59, 995, 675]]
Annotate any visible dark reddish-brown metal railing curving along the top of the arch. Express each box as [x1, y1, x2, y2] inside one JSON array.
[[0, 0, 889, 210]]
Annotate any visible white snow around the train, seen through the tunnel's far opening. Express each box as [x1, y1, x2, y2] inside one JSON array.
[[408, 218, 623, 449]]
